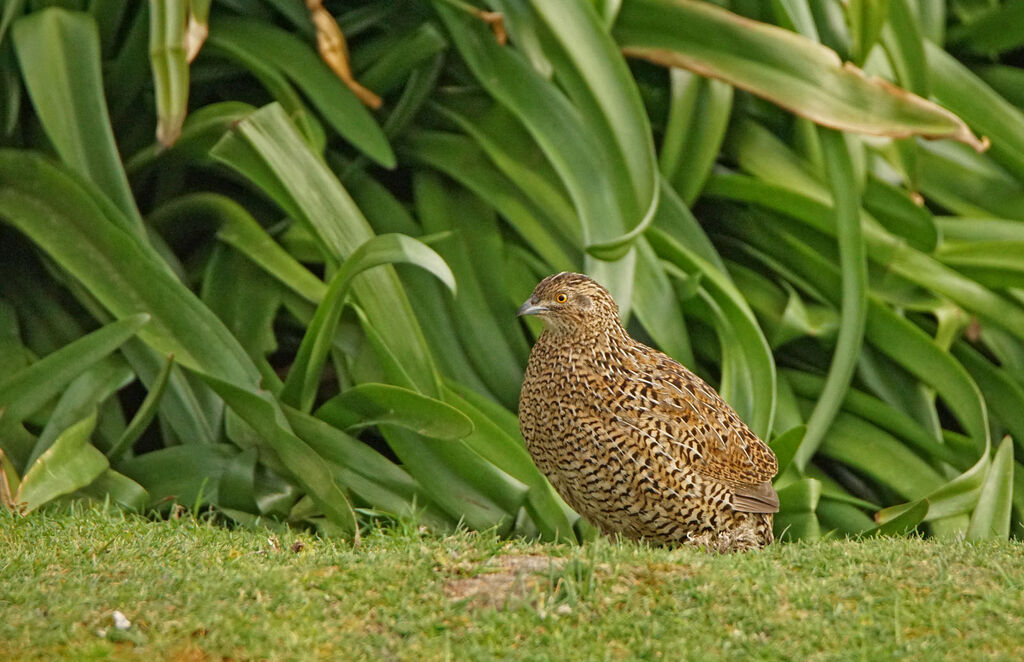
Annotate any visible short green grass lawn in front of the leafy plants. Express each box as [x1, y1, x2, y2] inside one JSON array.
[[0, 505, 1024, 660]]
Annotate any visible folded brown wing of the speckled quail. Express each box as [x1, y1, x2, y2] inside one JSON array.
[[618, 350, 778, 504]]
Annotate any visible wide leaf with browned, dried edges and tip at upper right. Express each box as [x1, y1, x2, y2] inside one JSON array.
[[614, 0, 983, 149]]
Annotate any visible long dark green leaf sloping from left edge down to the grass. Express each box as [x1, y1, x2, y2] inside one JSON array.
[[0, 150, 357, 534]]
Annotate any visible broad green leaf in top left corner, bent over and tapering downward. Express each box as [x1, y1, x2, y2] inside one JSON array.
[[13, 8, 143, 229]]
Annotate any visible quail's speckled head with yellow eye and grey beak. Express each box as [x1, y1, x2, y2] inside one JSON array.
[[519, 272, 618, 332]]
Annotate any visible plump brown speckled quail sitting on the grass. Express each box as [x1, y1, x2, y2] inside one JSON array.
[[518, 272, 778, 552]]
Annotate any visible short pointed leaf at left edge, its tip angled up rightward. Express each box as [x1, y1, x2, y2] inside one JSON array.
[[0, 315, 150, 436]]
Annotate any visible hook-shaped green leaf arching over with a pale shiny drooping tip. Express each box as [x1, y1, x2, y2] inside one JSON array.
[[281, 234, 456, 412]]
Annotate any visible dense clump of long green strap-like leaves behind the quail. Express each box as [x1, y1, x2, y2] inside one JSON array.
[[0, 0, 1024, 540]]
